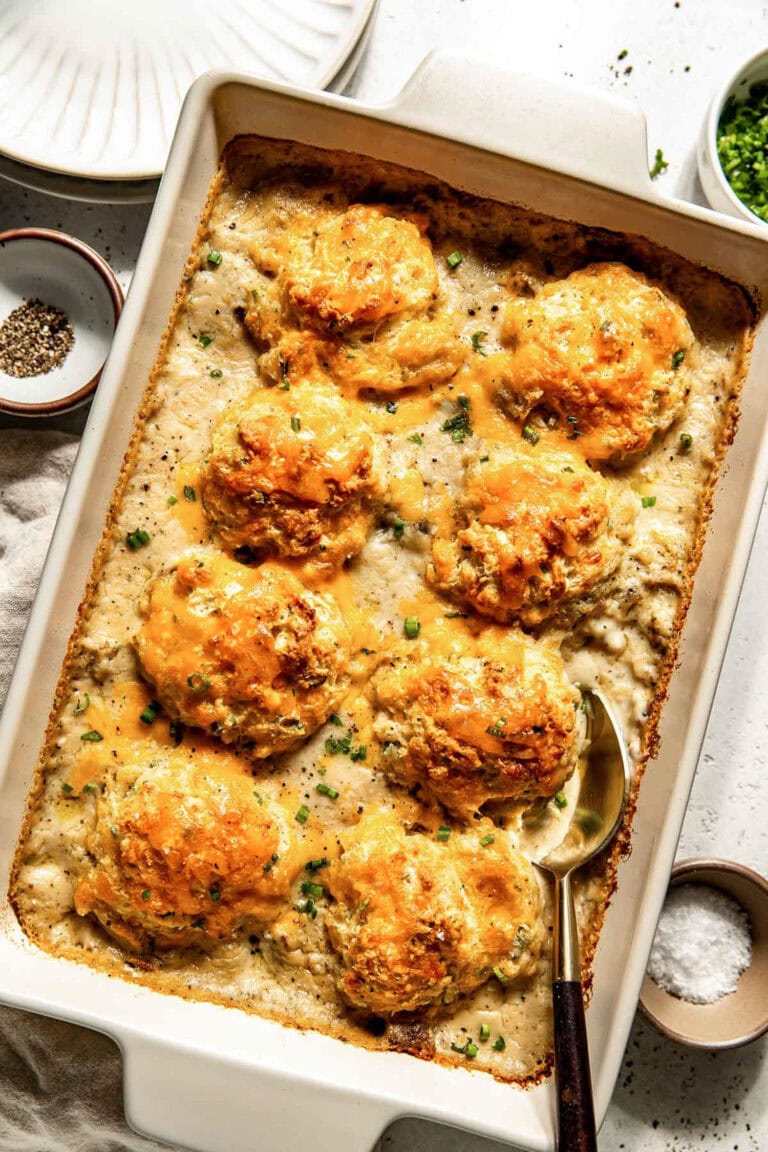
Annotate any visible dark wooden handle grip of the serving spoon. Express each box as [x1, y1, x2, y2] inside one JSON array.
[[552, 980, 598, 1152]]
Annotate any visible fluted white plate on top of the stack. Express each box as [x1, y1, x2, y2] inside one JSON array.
[[0, 0, 375, 180]]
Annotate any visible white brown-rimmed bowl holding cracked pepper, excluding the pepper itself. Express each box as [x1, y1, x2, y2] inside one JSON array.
[[0, 228, 123, 416]]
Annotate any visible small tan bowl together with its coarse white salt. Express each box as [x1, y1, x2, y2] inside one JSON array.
[[640, 858, 768, 1048]]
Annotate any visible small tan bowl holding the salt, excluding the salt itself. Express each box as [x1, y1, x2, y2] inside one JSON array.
[[640, 858, 768, 1049]]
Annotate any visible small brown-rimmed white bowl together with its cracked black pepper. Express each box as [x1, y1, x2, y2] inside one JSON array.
[[0, 228, 123, 416]]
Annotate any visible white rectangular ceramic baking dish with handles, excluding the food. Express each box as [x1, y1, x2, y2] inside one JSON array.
[[0, 54, 768, 1152]]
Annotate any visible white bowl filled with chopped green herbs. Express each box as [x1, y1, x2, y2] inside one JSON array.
[[698, 48, 768, 223]]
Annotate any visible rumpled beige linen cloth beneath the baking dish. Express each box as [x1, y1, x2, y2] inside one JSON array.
[[0, 429, 173, 1152]]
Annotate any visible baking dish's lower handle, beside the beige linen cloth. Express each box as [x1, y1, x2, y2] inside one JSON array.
[[121, 1034, 398, 1152]]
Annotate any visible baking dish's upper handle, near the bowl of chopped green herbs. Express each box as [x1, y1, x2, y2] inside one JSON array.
[[389, 50, 657, 199]]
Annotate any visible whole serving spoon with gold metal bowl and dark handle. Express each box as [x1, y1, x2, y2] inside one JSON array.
[[534, 688, 631, 1152]]
